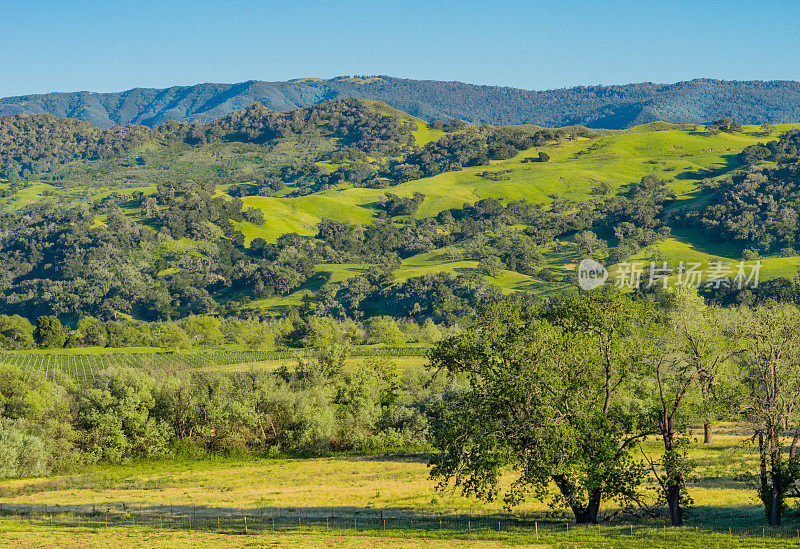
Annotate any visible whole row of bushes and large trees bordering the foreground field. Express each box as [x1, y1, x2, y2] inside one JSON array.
[[0, 288, 800, 525]]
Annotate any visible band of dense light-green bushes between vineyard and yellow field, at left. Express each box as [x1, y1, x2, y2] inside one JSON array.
[[0, 348, 442, 470]]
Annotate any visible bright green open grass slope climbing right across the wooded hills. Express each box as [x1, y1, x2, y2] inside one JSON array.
[[239, 124, 788, 234]]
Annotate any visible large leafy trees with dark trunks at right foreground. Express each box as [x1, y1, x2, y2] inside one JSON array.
[[430, 289, 800, 526]]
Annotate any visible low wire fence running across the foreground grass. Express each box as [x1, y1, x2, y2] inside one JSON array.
[[0, 505, 800, 544]]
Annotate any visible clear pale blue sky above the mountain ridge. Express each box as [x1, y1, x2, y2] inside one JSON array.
[[0, 0, 800, 96]]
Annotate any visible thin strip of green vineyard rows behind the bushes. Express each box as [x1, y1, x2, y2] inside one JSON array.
[[0, 347, 428, 383]]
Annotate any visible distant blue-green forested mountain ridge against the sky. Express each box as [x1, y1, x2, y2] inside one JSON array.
[[0, 76, 800, 129]]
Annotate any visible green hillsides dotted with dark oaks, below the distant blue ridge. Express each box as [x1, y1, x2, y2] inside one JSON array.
[[0, 99, 800, 322]]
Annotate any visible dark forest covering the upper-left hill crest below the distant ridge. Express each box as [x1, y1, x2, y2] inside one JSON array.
[[0, 98, 416, 179]]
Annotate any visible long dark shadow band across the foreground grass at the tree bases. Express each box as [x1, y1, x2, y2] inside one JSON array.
[[0, 500, 800, 539]]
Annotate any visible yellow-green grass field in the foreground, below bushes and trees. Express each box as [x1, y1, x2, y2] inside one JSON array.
[[0, 425, 800, 547]]
